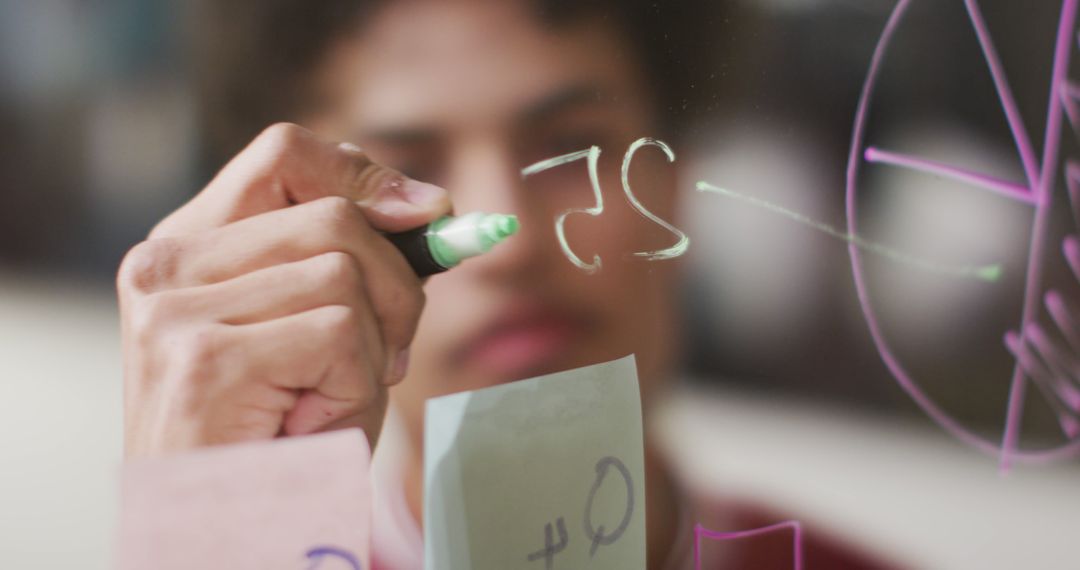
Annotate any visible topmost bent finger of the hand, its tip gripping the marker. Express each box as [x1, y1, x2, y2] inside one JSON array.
[[151, 123, 449, 238]]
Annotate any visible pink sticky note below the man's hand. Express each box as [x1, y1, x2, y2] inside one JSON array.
[[118, 430, 372, 570]]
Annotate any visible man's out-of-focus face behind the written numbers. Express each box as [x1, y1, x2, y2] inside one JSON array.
[[311, 0, 676, 438]]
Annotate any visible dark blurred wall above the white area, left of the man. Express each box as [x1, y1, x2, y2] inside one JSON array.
[[0, 0, 195, 282]]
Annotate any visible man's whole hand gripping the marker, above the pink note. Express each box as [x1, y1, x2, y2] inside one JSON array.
[[117, 124, 449, 456]]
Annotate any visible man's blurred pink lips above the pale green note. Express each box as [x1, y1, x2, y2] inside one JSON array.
[[458, 309, 584, 379]]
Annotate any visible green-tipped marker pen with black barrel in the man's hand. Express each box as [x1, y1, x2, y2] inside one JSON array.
[[387, 212, 518, 277]]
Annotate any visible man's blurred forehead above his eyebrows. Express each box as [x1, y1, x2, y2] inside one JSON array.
[[341, 1, 627, 131]]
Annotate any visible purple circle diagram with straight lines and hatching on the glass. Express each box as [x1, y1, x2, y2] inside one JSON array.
[[845, 0, 1080, 472]]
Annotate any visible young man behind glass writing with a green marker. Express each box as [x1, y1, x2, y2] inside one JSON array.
[[118, 0, 894, 569]]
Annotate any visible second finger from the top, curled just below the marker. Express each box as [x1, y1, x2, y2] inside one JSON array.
[[129, 198, 424, 351]]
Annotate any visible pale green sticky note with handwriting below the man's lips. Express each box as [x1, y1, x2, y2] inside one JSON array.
[[423, 356, 645, 570]]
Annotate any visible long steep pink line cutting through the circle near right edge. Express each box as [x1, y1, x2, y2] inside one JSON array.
[[1000, 0, 1077, 473]]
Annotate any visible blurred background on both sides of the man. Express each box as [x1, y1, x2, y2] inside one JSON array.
[[0, 0, 1080, 568]]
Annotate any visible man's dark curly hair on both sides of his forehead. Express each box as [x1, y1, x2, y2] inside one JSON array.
[[191, 0, 728, 167]]
